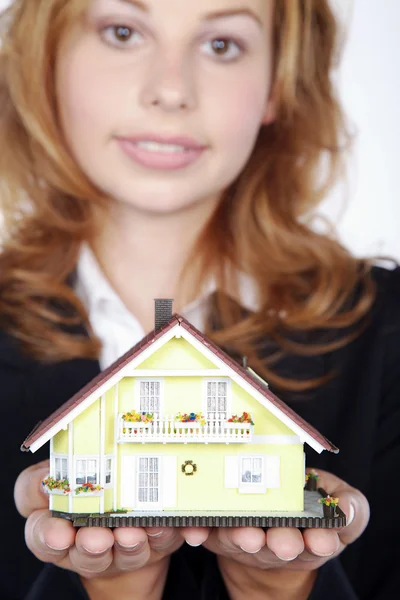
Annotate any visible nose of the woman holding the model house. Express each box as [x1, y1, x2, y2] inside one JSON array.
[[142, 52, 196, 112]]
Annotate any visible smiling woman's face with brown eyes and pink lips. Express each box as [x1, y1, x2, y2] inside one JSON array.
[[56, 0, 273, 214]]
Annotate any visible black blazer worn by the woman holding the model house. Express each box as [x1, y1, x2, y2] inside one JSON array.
[[0, 268, 400, 600]]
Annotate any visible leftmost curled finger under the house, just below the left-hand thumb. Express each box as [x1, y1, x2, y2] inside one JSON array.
[[25, 509, 75, 564]]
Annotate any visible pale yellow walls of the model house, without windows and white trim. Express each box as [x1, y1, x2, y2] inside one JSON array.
[[54, 338, 304, 512]]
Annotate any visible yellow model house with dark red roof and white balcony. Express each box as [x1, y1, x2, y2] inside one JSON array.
[[21, 300, 344, 527]]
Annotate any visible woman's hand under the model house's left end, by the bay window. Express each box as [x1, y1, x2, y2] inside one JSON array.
[[14, 460, 208, 579]]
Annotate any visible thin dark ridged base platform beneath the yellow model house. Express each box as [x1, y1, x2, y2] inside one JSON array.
[[52, 488, 346, 529]]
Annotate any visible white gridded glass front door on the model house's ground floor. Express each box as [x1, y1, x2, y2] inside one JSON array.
[[136, 456, 160, 510]]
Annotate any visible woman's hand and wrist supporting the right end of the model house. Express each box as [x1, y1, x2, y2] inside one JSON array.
[[204, 469, 369, 599]]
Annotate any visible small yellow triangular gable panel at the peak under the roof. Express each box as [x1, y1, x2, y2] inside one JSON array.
[[136, 338, 218, 369]]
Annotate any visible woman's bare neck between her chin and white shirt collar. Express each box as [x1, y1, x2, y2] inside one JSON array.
[[92, 197, 215, 331]]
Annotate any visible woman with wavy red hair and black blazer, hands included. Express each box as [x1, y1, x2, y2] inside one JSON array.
[[0, 0, 400, 600]]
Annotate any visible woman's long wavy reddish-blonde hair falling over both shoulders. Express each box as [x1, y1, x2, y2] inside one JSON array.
[[0, 0, 375, 390]]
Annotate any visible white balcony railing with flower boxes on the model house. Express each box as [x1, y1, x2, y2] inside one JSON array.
[[117, 413, 254, 444]]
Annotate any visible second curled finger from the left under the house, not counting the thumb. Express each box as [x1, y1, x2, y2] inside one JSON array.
[[69, 527, 114, 578]]
